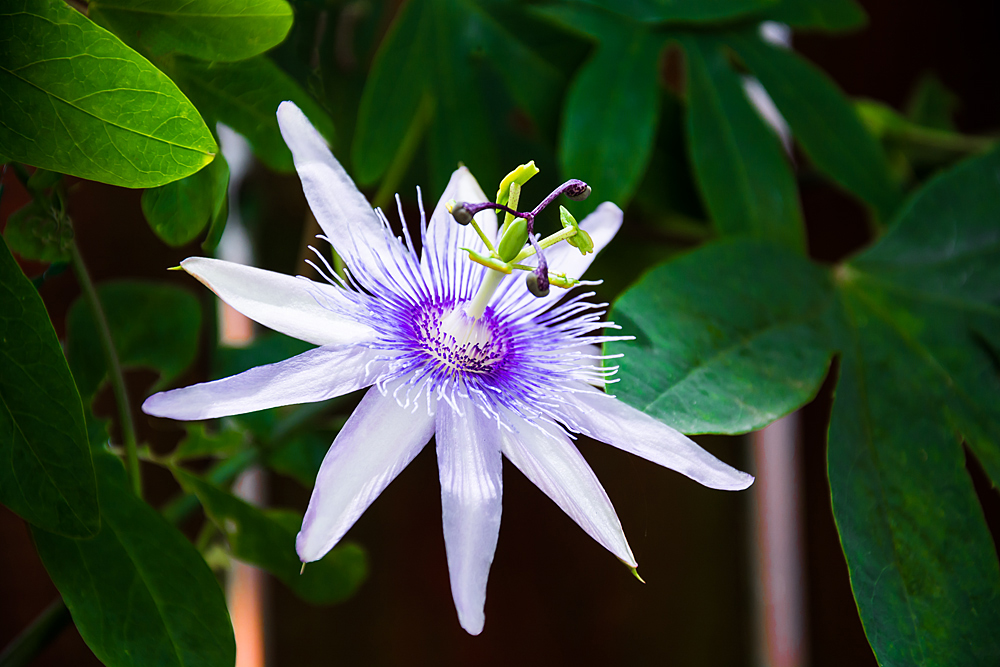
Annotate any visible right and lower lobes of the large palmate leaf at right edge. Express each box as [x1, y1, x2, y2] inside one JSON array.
[[829, 152, 1000, 665]]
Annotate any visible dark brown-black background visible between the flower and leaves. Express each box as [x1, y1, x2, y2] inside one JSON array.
[[0, 0, 1000, 667]]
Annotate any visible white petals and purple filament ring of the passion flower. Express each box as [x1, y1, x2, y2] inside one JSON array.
[[143, 102, 753, 634]]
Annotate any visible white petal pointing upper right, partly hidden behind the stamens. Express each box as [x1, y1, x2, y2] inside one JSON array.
[[493, 202, 624, 315]]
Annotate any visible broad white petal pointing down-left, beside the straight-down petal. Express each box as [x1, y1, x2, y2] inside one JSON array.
[[295, 386, 434, 563]]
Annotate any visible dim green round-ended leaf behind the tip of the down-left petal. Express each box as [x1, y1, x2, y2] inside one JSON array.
[[174, 468, 368, 604]]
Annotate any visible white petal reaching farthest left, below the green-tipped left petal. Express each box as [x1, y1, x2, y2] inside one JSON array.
[[142, 346, 378, 420]]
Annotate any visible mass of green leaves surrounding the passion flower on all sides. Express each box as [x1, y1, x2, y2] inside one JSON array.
[[0, 0, 1000, 665]]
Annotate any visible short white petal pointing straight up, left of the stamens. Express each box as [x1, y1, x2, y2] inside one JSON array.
[[421, 167, 497, 298]]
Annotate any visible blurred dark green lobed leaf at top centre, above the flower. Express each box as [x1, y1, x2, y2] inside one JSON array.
[[351, 0, 562, 191]]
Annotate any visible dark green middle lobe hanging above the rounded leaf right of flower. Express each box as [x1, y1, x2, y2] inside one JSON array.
[[681, 35, 805, 250]]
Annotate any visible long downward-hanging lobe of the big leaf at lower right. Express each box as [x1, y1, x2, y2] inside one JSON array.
[[828, 284, 1000, 666]]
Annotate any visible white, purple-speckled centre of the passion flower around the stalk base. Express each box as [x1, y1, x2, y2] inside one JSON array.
[[418, 304, 507, 375]]
